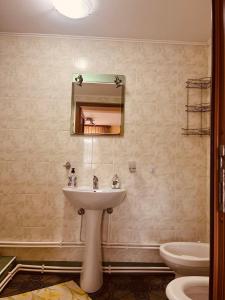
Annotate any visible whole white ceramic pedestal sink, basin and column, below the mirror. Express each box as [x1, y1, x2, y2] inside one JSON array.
[[63, 187, 126, 293]]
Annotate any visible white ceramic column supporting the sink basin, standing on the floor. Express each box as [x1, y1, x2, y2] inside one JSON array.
[[80, 209, 103, 293]]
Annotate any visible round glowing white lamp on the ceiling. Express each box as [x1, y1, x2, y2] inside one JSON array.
[[52, 0, 96, 19]]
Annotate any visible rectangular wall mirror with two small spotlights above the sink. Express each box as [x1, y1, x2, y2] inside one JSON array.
[[71, 74, 125, 135]]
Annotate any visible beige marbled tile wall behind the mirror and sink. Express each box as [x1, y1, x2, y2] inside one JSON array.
[[0, 35, 208, 261]]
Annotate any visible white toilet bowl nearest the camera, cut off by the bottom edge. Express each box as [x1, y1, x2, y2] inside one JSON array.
[[166, 276, 209, 300]]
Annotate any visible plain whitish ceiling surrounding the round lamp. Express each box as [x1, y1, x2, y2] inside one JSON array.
[[0, 0, 211, 42]]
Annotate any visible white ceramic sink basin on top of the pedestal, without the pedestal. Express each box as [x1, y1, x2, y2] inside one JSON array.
[[63, 186, 126, 210]]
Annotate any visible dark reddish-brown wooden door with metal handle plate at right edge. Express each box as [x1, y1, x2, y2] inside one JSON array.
[[210, 0, 225, 300]]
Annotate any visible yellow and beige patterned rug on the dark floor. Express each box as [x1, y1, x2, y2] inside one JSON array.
[[1, 281, 91, 300]]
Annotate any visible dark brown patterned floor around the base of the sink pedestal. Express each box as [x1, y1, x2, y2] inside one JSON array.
[[0, 272, 174, 300]]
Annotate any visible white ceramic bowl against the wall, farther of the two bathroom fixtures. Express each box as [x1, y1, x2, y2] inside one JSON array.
[[160, 242, 209, 276]]
